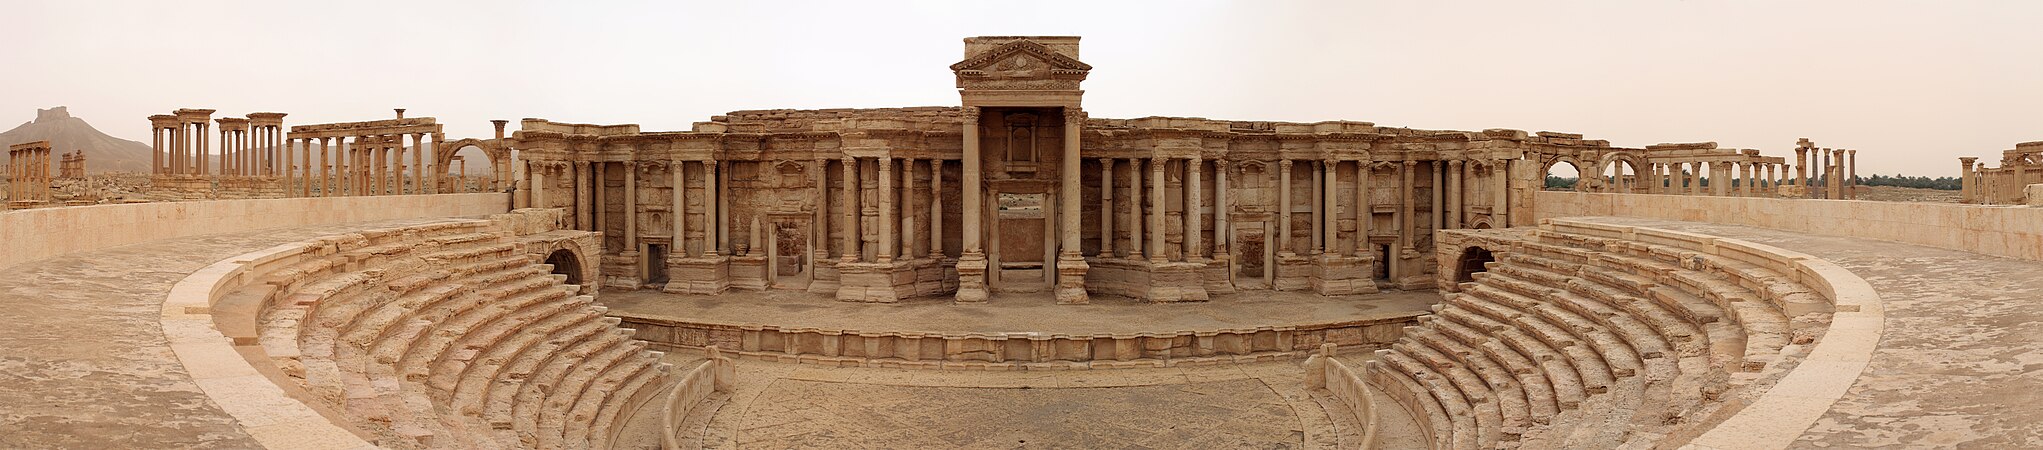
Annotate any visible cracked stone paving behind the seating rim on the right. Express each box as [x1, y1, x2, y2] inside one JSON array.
[[1577, 217, 2043, 448]]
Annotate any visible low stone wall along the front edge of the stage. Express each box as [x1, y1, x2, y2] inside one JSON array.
[[611, 311, 1418, 370]]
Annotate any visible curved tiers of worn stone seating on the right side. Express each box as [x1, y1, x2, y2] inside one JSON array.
[[1367, 225, 1831, 448]]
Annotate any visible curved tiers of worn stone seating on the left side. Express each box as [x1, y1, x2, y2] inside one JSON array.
[[257, 221, 676, 448]]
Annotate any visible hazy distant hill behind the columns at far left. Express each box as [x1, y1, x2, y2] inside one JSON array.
[[0, 106, 151, 174]]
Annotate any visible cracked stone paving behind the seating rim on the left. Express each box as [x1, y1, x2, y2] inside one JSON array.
[[0, 219, 463, 448]]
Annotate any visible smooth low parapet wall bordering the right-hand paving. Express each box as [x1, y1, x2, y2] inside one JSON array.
[[1532, 192, 2043, 260]]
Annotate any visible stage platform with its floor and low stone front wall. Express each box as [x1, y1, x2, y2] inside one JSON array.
[[599, 290, 1438, 370]]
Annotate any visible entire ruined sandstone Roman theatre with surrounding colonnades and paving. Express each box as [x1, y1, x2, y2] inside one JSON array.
[[0, 37, 2043, 450]]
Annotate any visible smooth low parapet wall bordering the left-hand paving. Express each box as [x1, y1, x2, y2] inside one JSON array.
[[0, 192, 511, 268]]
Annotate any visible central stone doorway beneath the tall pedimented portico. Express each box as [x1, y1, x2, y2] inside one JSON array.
[[993, 192, 1056, 293]]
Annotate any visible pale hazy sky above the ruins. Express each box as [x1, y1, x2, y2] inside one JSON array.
[[0, 0, 2043, 176]]
